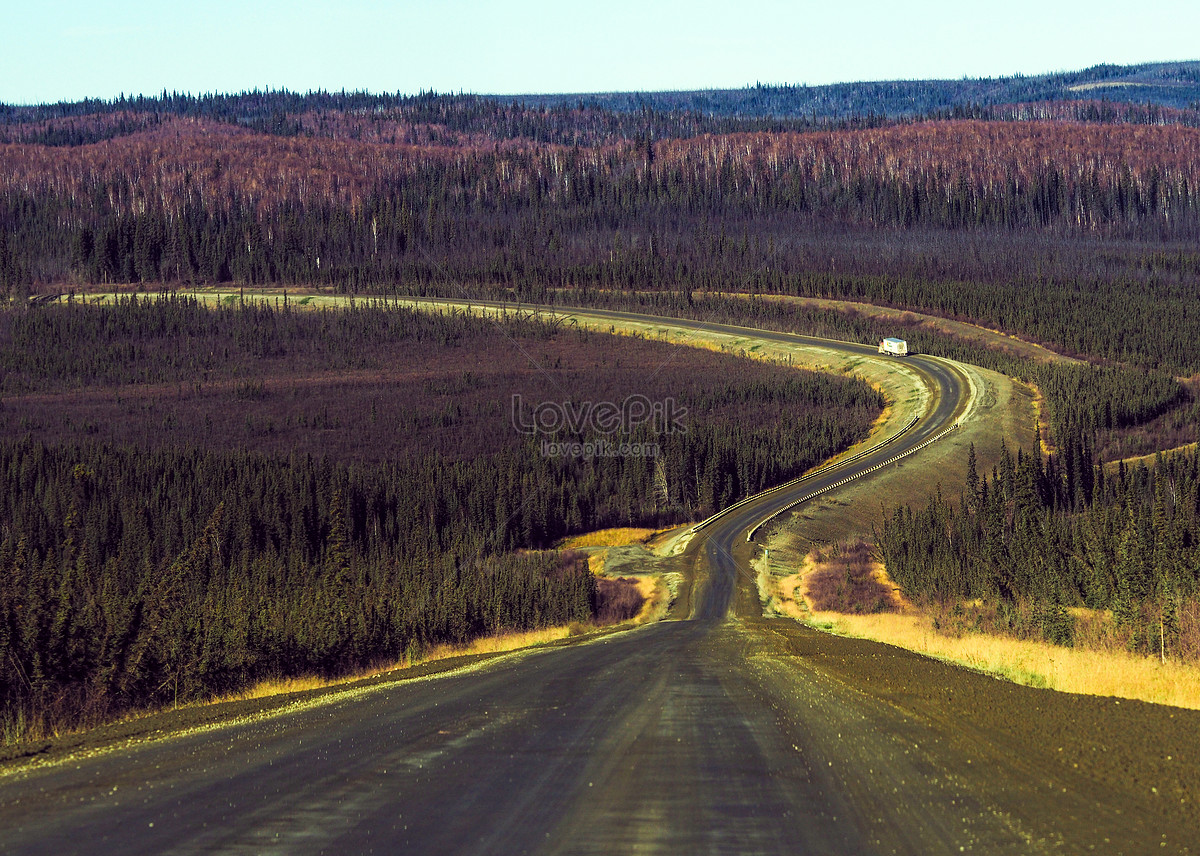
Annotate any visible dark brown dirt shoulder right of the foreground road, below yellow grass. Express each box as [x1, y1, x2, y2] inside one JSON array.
[[748, 618, 1200, 840]]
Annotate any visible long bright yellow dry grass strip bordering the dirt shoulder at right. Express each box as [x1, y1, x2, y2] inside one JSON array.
[[810, 612, 1200, 710]]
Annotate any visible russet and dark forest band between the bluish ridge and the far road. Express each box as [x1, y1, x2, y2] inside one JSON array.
[[7, 116, 1200, 291]]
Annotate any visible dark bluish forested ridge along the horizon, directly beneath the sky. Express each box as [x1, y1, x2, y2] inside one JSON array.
[[0, 60, 1200, 137]]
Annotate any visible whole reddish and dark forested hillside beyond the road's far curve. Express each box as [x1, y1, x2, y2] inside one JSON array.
[[0, 84, 1200, 384]]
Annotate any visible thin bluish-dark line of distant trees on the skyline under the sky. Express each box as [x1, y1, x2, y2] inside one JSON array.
[[0, 62, 1200, 130]]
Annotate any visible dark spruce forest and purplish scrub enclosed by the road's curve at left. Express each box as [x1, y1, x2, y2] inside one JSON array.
[[0, 297, 882, 731]]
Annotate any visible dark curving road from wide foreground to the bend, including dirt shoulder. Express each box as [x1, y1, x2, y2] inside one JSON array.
[[0, 309, 1200, 854]]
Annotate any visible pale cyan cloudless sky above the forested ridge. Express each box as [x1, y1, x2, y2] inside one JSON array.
[[0, 0, 1200, 104]]
